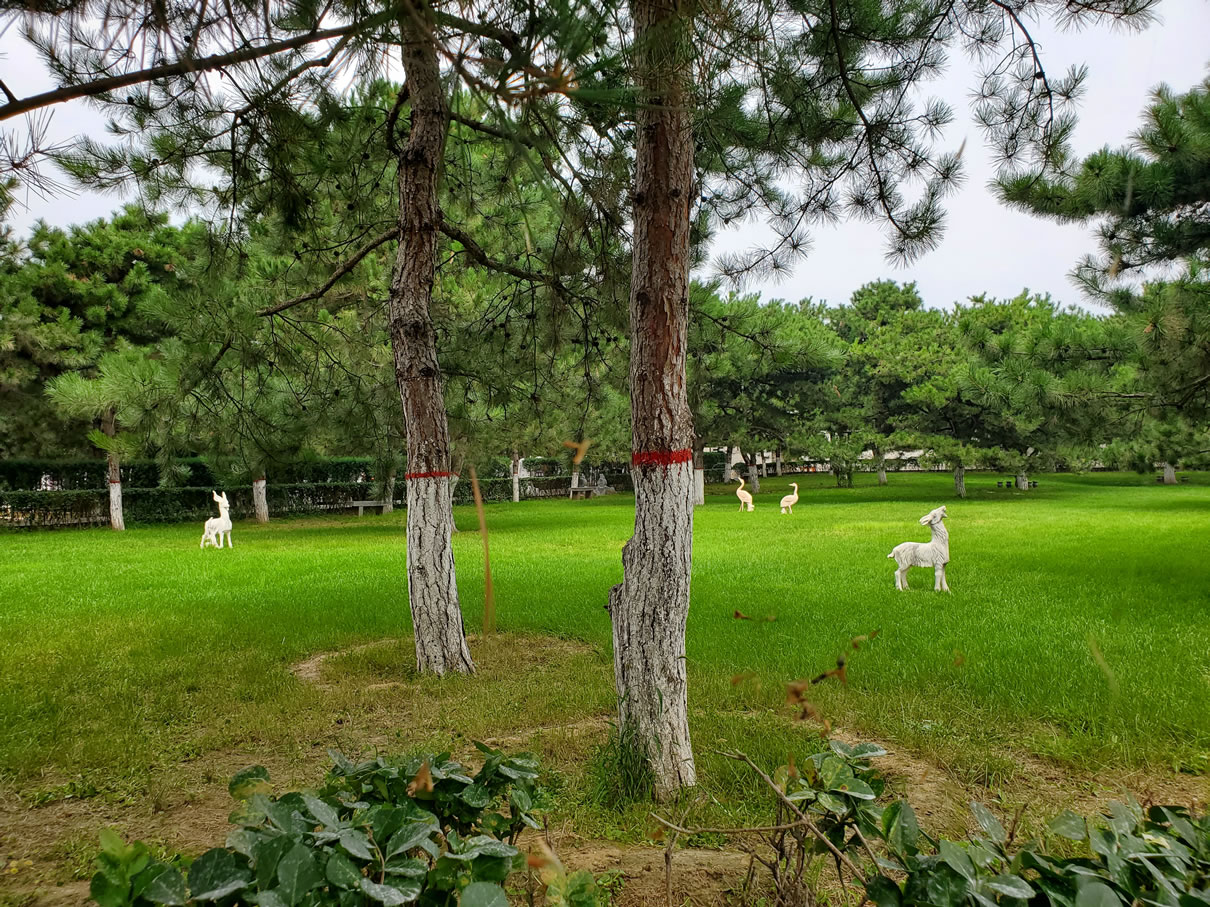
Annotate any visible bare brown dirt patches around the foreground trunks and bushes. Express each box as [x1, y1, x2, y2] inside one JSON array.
[[0, 641, 1210, 907]]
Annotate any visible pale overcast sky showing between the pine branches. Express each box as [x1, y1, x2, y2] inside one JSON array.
[[0, 0, 1210, 306]]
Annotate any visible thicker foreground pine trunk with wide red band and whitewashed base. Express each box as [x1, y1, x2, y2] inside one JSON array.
[[609, 0, 697, 799]]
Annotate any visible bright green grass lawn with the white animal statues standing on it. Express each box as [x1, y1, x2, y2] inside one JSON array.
[[0, 474, 1210, 899]]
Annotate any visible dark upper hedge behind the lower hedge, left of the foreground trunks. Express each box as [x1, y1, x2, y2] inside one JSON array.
[[0, 457, 373, 491]]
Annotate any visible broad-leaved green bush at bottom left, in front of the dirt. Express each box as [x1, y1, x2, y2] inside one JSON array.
[[91, 744, 595, 907]]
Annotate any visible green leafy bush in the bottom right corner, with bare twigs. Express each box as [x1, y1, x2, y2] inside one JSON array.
[[736, 740, 1210, 907]]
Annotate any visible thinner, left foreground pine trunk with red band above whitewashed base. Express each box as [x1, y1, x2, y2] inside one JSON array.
[[387, 10, 474, 675]]
